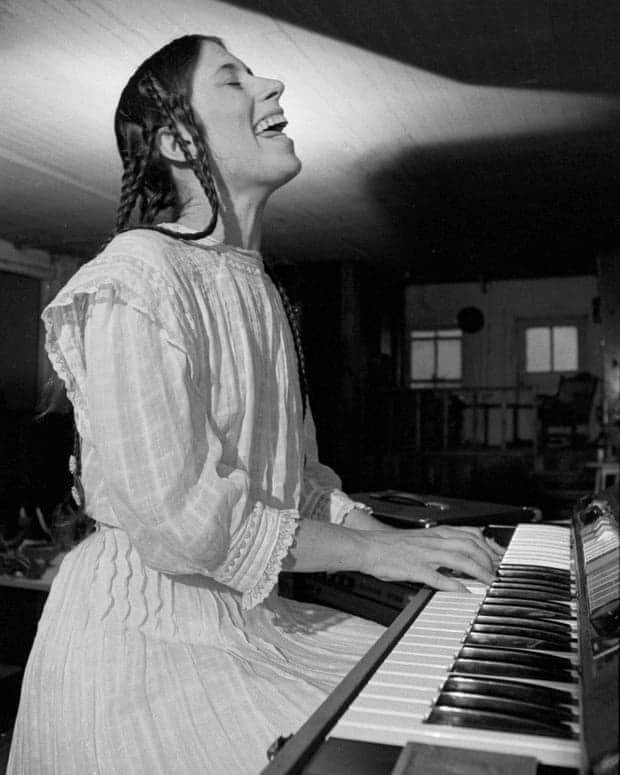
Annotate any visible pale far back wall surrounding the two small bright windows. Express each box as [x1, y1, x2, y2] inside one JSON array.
[[405, 275, 602, 446]]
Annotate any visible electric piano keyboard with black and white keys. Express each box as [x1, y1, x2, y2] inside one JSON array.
[[262, 492, 620, 775]]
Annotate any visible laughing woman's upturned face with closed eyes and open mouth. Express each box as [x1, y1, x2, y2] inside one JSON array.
[[192, 41, 301, 199]]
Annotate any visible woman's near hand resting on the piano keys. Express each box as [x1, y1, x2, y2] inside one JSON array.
[[361, 526, 503, 591]]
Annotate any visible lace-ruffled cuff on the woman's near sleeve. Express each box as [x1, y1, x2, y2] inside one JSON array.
[[214, 503, 299, 609]]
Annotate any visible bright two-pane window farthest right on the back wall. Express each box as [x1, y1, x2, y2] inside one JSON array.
[[525, 325, 579, 374]]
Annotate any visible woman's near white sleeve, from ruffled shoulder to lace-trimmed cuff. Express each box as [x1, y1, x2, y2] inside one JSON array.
[[44, 262, 299, 608]]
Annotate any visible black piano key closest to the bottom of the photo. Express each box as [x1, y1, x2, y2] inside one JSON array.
[[425, 705, 575, 739]]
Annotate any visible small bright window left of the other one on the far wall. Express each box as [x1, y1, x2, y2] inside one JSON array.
[[411, 328, 462, 387]]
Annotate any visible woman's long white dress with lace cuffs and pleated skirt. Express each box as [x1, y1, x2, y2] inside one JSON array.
[[8, 230, 383, 775]]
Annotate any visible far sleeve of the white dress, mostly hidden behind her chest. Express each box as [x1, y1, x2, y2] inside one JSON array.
[[299, 406, 372, 525]]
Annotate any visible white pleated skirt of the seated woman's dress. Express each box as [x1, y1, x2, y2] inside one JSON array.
[[7, 527, 383, 775]]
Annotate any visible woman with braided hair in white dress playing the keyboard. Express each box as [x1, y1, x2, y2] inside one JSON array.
[[8, 36, 496, 775]]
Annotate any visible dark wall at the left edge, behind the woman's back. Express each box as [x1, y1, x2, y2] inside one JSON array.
[[0, 239, 79, 532]]
